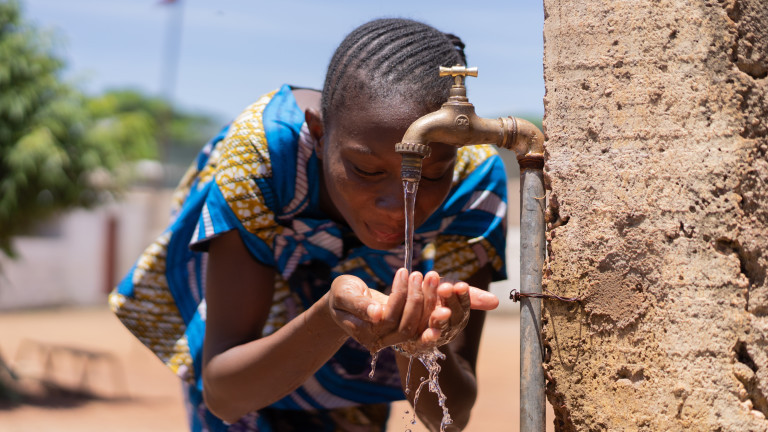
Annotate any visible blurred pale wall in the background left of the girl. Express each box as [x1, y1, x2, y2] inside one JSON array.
[[0, 188, 170, 310]]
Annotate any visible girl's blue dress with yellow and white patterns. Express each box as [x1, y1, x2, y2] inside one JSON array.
[[109, 86, 507, 431]]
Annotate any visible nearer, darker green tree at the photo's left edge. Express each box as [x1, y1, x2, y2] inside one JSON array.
[[0, 0, 110, 254]]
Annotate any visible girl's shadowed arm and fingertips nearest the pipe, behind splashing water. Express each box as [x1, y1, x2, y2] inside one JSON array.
[[397, 266, 498, 431]]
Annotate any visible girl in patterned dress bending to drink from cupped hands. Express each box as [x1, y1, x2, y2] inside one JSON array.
[[110, 19, 506, 431]]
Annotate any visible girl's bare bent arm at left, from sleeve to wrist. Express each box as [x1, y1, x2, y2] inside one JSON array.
[[203, 231, 347, 422]]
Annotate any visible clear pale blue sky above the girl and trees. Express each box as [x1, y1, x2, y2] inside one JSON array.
[[20, 0, 544, 120]]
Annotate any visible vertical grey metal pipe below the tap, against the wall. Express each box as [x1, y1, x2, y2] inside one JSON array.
[[520, 161, 546, 432]]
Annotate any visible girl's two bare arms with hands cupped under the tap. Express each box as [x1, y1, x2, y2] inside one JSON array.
[[203, 231, 498, 425]]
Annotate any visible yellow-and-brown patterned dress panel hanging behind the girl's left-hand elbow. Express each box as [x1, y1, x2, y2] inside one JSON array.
[[109, 232, 195, 382]]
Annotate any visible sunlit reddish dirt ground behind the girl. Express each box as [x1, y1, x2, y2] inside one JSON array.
[[0, 306, 554, 432]]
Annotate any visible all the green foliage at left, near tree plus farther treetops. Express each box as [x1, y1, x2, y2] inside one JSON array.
[[0, 0, 214, 255]]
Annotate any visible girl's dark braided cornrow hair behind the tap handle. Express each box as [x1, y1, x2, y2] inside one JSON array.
[[322, 18, 467, 122]]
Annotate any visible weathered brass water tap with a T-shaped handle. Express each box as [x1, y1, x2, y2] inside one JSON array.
[[395, 65, 544, 181]]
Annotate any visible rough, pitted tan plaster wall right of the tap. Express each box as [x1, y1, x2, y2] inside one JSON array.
[[544, 0, 768, 432]]
